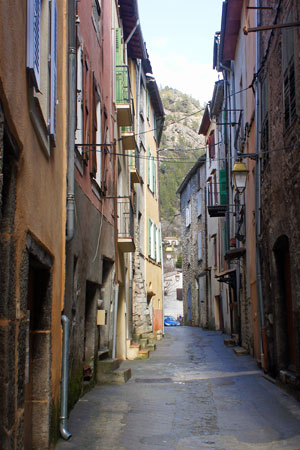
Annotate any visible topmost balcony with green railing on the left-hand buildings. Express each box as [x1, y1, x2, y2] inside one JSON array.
[[116, 65, 132, 127]]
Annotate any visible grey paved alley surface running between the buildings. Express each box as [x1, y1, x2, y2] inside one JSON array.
[[56, 327, 300, 450]]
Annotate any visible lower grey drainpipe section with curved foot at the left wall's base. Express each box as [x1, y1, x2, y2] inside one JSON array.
[[59, 314, 72, 441]]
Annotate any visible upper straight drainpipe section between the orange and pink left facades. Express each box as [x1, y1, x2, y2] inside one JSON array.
[[66, 0, 76, 242]]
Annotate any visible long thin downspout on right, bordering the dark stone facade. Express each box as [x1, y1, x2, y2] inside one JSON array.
[[255, 0, 268, 371]]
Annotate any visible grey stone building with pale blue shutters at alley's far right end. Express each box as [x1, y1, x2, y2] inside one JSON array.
[[177, 156, 208, 327]]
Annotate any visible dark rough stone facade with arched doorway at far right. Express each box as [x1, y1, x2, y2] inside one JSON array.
[[259, 0, 300, 377]]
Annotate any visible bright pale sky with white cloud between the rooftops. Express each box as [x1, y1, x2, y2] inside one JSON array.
[[138, 0, 223, 104]]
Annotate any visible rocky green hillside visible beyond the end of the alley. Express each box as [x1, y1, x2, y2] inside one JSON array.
[[159, 87, 203, 237]]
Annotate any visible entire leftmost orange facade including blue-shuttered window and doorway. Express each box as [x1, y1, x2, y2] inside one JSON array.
[[0, 0, 67, 450]]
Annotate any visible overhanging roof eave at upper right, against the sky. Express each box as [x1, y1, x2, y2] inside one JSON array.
[[220, 0, 243, 64]]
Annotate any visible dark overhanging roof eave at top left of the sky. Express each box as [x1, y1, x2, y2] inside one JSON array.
[[118, 0, 147, 59]]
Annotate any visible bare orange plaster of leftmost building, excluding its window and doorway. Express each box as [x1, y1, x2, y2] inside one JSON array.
[[0, 1, 67, 448]]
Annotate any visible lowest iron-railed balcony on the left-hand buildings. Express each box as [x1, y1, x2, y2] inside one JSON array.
[[118, 198, 135, 253]]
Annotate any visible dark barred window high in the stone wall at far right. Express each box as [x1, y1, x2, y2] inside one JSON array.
[[282, 13, 296, 130]]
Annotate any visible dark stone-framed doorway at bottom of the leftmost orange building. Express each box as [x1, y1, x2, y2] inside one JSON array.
[[24, 256, 51, 450]]
